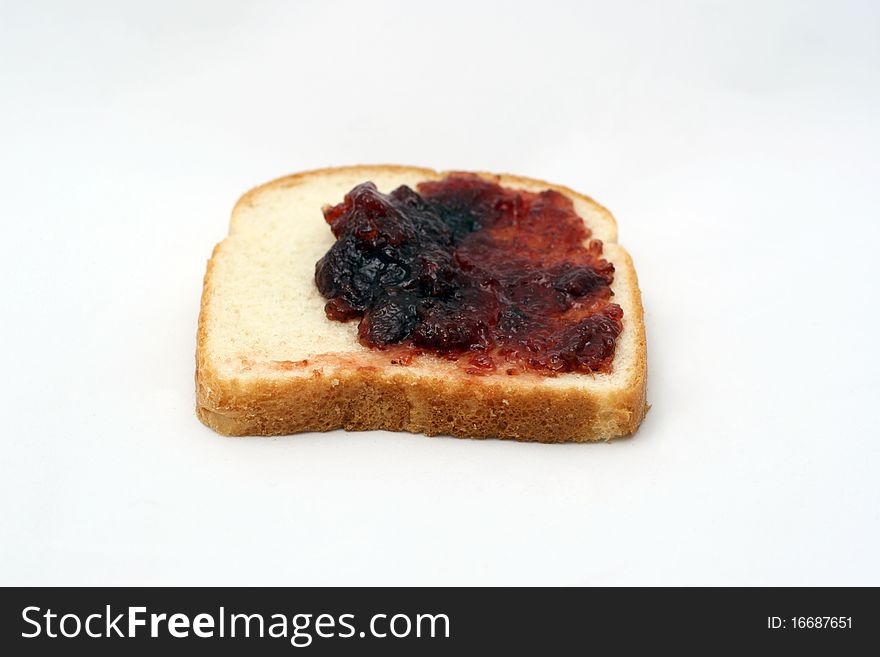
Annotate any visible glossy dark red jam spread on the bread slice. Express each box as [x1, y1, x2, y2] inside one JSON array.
[[315, 174, 623, 375]]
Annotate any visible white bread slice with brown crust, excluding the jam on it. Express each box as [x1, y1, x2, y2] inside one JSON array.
[[196, 166, 647, 442]]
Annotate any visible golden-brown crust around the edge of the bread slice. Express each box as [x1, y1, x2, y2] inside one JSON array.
[[196, 165, 647, 443]]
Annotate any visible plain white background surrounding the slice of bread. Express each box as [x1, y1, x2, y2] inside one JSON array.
[[0, 0, 880, 585]]
